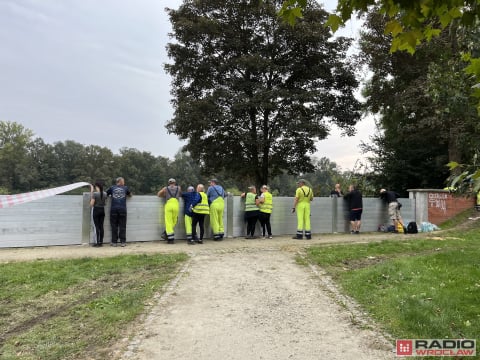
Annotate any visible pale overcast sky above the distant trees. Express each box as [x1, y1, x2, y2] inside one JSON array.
[[0, 0, 373, 170]]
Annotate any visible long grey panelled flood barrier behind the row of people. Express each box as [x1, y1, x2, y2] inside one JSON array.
[[0, 193, 415, 247]]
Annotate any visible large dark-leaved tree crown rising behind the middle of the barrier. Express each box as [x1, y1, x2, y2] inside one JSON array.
[[166, 0, 360, 184]]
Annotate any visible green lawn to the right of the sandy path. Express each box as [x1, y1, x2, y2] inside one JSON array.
[[307, 229, 480, 351]]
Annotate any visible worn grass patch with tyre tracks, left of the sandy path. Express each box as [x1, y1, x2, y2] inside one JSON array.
[[0, 254, 187, 360]]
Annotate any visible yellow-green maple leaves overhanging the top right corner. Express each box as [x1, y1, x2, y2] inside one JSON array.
[[279, 0, 480, 113]]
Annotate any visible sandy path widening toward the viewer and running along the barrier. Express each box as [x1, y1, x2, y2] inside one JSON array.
[[0, 234, 405, 360]]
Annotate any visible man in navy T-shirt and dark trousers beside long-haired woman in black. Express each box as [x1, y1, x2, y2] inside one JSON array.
[[107, 177, 132, 246]]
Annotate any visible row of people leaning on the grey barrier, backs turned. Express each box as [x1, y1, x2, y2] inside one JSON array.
[[90, 177, 404, 246]]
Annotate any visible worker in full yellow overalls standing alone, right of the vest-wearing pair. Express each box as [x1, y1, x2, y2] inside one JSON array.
[[292, 179, 313, 240]]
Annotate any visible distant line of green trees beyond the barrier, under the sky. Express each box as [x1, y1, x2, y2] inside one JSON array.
[[0, 121, 362, 196]]
